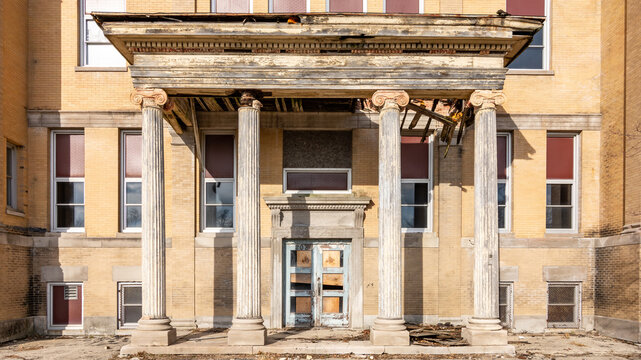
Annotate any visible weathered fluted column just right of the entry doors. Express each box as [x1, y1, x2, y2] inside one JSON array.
[[370, 91, 409, 345]]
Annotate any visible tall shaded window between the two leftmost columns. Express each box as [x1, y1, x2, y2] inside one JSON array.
[[202, 135, 236, 231]]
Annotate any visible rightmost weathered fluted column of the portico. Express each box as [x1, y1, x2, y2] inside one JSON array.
[[463, 90, 507, 345]]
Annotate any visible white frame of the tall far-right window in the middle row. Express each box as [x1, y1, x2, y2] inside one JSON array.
[[545, 132, 581, 234]]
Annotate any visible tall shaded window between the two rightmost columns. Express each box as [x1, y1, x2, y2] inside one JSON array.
[[401, 136, 432, 232]]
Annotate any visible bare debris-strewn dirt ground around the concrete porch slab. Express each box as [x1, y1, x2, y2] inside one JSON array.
[[0, 332, 641, 360]]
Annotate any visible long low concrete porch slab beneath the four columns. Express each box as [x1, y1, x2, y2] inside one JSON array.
[[120, 336, 515, 356]]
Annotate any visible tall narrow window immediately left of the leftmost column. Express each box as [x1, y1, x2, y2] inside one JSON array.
[[120, 131, 142, 232]]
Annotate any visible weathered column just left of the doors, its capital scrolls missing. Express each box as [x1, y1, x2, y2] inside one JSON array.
[[227, 92, 266, 345]]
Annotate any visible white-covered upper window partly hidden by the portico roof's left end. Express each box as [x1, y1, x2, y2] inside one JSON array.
[[80, 0, 127, 67]]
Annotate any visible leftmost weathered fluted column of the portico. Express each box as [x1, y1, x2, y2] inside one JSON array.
[[131, 89, 176, 345]]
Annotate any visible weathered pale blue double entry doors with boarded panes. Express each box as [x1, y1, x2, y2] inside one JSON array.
[[284, 240, 350, 327]]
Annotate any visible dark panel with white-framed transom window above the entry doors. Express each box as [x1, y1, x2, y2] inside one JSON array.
[[283, 131, 352, 194]]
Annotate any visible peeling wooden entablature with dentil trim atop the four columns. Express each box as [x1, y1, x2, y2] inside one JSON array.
[[94, 13, 543, 98]]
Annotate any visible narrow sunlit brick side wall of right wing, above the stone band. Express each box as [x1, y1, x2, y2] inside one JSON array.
[[599, 0, 625, 235]]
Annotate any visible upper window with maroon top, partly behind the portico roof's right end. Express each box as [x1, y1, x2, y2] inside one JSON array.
[[507, 0, 550, 70]]
